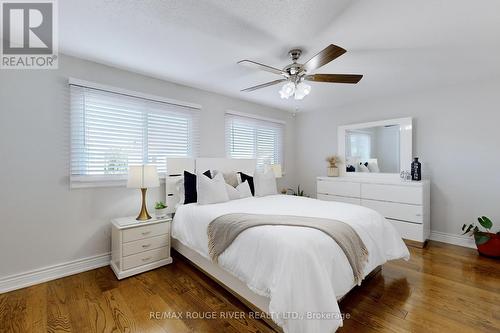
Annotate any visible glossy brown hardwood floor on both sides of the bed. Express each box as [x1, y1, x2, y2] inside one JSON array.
[[0, 242, 500, 333]]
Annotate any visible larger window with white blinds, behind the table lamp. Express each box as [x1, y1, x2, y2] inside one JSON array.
[[70, 85, 199, 186]]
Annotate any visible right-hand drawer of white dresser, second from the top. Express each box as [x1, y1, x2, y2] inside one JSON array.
[[361, 199, 424, 224]]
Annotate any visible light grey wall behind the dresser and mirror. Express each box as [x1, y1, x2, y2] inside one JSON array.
[[296, 80, 500, 234]]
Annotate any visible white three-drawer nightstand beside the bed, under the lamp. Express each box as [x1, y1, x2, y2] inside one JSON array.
[[111, 217, 172, 279]]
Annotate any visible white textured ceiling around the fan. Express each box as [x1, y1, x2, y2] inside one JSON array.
[[59, 0, 500, 111]]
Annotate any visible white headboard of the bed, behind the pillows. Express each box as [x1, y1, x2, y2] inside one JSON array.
[[165, 157, 257, 213]]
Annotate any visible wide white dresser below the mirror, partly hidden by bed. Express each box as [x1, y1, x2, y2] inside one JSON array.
[[317, 177, 430, 247]]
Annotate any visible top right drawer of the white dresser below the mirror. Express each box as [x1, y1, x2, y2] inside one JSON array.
[[361, 184, 423, 205]]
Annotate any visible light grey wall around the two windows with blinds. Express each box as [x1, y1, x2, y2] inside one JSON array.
[[0, 56, 295, 279]]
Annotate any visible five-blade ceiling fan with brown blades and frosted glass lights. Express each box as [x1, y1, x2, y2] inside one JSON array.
[[238, 44, 363, 100]]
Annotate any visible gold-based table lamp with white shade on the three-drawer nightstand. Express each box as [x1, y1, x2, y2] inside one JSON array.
[[127, 165, 160, 221]]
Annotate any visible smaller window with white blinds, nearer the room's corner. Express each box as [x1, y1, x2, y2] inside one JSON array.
[[225, 113, 285, 169]]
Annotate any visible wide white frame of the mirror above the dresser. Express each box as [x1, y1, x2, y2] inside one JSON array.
[[338, 117, 413, 178]]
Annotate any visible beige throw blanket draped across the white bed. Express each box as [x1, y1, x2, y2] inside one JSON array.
[[208, 213, 368, 285]]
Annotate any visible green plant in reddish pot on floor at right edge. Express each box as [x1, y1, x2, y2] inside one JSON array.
[[462, 216, 500, 258]]
